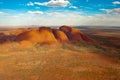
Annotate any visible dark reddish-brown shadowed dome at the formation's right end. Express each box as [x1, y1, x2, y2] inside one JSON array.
[[59, 26, 94, 42]]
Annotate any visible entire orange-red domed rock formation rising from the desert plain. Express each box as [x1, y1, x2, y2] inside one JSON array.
[[0, 26, 95, 45]]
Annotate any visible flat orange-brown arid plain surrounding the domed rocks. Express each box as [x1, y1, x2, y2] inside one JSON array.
[[0, 27, 120, 80]]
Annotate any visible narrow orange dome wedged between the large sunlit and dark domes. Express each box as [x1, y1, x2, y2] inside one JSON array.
[[52, 29, 69, 42]]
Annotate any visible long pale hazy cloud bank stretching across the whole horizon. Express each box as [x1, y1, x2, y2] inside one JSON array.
[[0, 11, 120, 26]]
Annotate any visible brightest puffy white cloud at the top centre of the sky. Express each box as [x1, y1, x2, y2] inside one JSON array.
[[34, 0, 70, 7]]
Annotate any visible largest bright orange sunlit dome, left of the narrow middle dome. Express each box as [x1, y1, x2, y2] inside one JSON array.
[[16, 27, 57, 44]]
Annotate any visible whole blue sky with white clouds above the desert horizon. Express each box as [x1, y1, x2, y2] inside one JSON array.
[[0, 0, 120, 26]]
